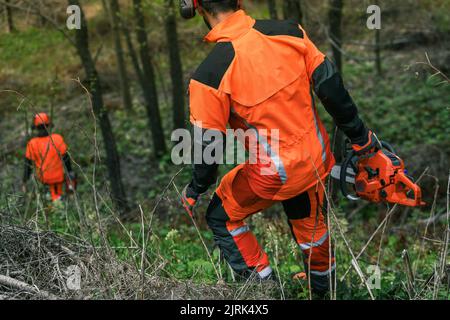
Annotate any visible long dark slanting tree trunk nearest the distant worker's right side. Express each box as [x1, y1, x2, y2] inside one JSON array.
[[68, 0, 128, 214]]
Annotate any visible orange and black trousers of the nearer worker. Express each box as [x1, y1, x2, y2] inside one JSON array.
[[206, 178, 336, 282]]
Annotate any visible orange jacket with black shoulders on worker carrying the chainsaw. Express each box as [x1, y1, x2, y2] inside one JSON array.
[[189, 10, 334, 205]]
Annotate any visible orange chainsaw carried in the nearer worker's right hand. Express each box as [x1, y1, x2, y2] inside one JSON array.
[[331, 141, 425, 207]]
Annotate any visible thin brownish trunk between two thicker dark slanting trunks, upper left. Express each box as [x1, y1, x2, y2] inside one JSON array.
[[103, 0, 133, 111]]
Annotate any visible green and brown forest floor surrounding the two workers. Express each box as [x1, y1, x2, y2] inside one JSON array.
[[0, 1, 450, 299]]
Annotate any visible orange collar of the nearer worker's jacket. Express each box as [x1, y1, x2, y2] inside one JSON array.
[[204, 10, 255, 42]]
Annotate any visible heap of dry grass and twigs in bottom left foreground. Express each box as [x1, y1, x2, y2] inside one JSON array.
[[0, 225, 282, 300]]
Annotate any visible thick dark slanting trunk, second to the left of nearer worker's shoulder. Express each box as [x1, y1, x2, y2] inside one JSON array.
[[133, 0, 166, 158]]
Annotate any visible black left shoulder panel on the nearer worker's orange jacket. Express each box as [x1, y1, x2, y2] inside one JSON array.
[[192, 42, 235, 89]]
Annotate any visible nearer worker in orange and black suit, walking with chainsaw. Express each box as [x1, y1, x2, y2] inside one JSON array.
[[181, 0, 379, 294]]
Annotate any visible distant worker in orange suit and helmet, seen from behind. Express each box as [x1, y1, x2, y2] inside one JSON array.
[[23, 113, 76, 201]]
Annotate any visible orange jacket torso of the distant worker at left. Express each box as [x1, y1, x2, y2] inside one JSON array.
[[25, 134, 67, 185]]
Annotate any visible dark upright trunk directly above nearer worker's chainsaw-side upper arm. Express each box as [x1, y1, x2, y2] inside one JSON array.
[[328, 0, 343, 73]]
